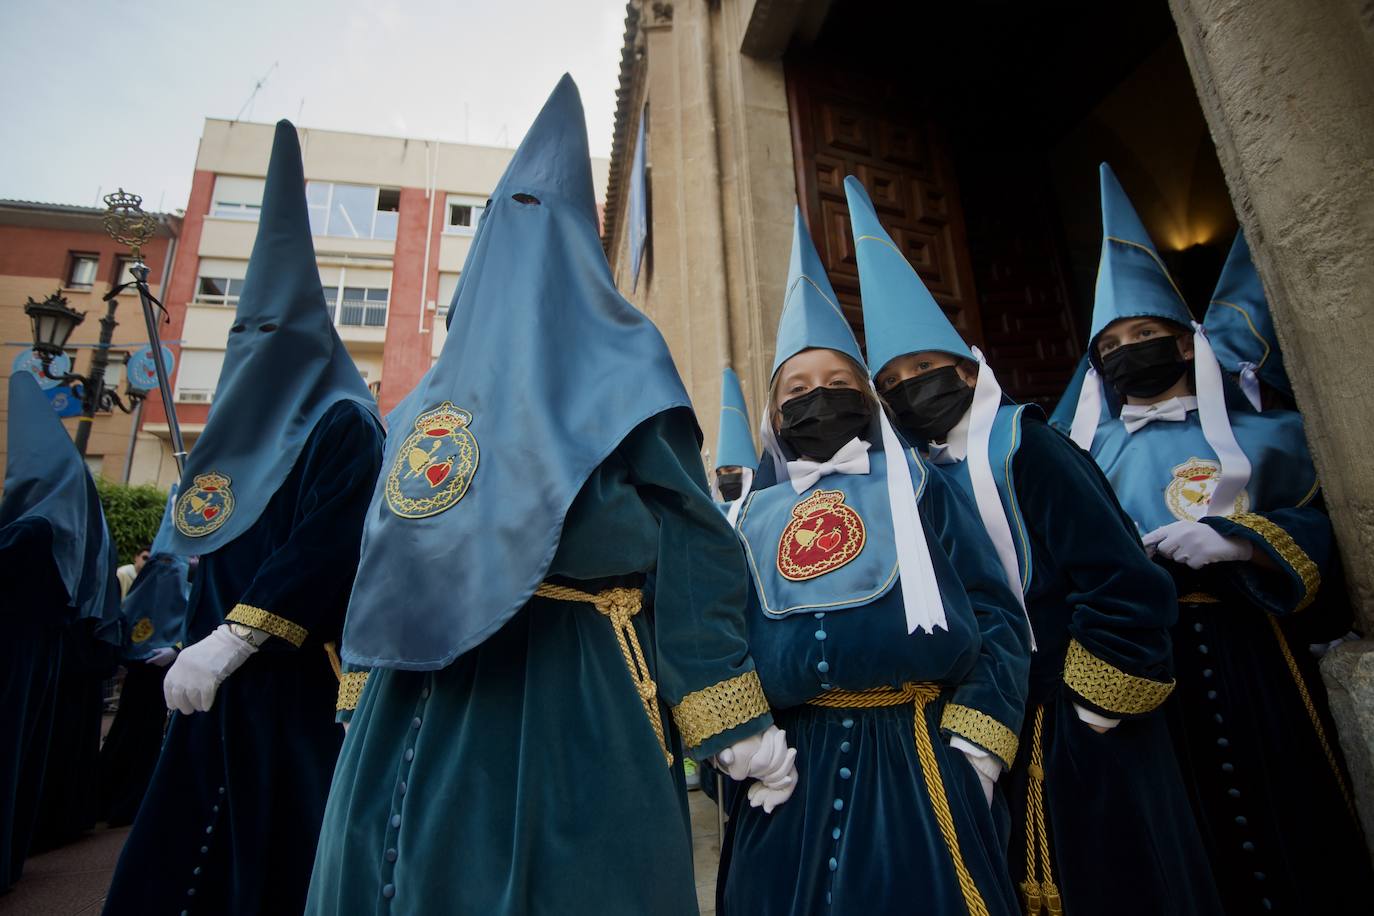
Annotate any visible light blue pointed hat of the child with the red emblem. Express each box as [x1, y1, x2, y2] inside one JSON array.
[[769, 207, 864, 378]]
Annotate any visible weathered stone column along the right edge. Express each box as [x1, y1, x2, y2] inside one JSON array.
[[1169, 0, 1374, 838]]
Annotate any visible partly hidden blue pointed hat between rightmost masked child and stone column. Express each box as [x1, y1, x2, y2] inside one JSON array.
[[1202, 232, 1293, 397]]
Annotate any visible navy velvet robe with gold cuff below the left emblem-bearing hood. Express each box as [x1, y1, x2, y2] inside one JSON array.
[[104, 401, 382, 916]]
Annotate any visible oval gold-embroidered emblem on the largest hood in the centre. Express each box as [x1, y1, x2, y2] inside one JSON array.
[[386, 401, 478, 518]]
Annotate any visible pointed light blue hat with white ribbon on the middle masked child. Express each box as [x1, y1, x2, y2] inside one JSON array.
[[845, 176, 1031, 631]]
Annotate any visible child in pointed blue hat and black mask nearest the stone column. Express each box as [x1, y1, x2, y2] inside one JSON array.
[[1073, 163, 1371, 913]]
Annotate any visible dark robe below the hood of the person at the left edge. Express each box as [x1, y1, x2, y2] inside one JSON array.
[[0, 518, 64, 894]]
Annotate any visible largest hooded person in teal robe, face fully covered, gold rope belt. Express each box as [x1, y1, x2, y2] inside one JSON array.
[[306, 76, 791, 916]]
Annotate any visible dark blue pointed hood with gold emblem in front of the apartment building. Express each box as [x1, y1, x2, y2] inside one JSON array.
[[153, 121, 376, 556]]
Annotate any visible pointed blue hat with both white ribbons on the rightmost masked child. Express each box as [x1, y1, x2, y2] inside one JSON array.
[[1070, 162, 1250, 515]]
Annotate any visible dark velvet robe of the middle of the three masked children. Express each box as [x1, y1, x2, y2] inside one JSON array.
[[937, 417, 1220, 916]]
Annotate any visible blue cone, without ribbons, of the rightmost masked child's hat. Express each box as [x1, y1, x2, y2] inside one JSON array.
[[1088, 162, 1193, 369]]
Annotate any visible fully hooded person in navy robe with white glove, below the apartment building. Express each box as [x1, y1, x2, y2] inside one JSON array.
[[106, 121, 382, 916]]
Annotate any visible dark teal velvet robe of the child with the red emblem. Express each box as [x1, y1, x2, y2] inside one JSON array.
[[716, 457, 1029, 916]]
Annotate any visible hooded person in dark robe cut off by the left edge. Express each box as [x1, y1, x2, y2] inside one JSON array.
[[0, 372, 120, 893]]
